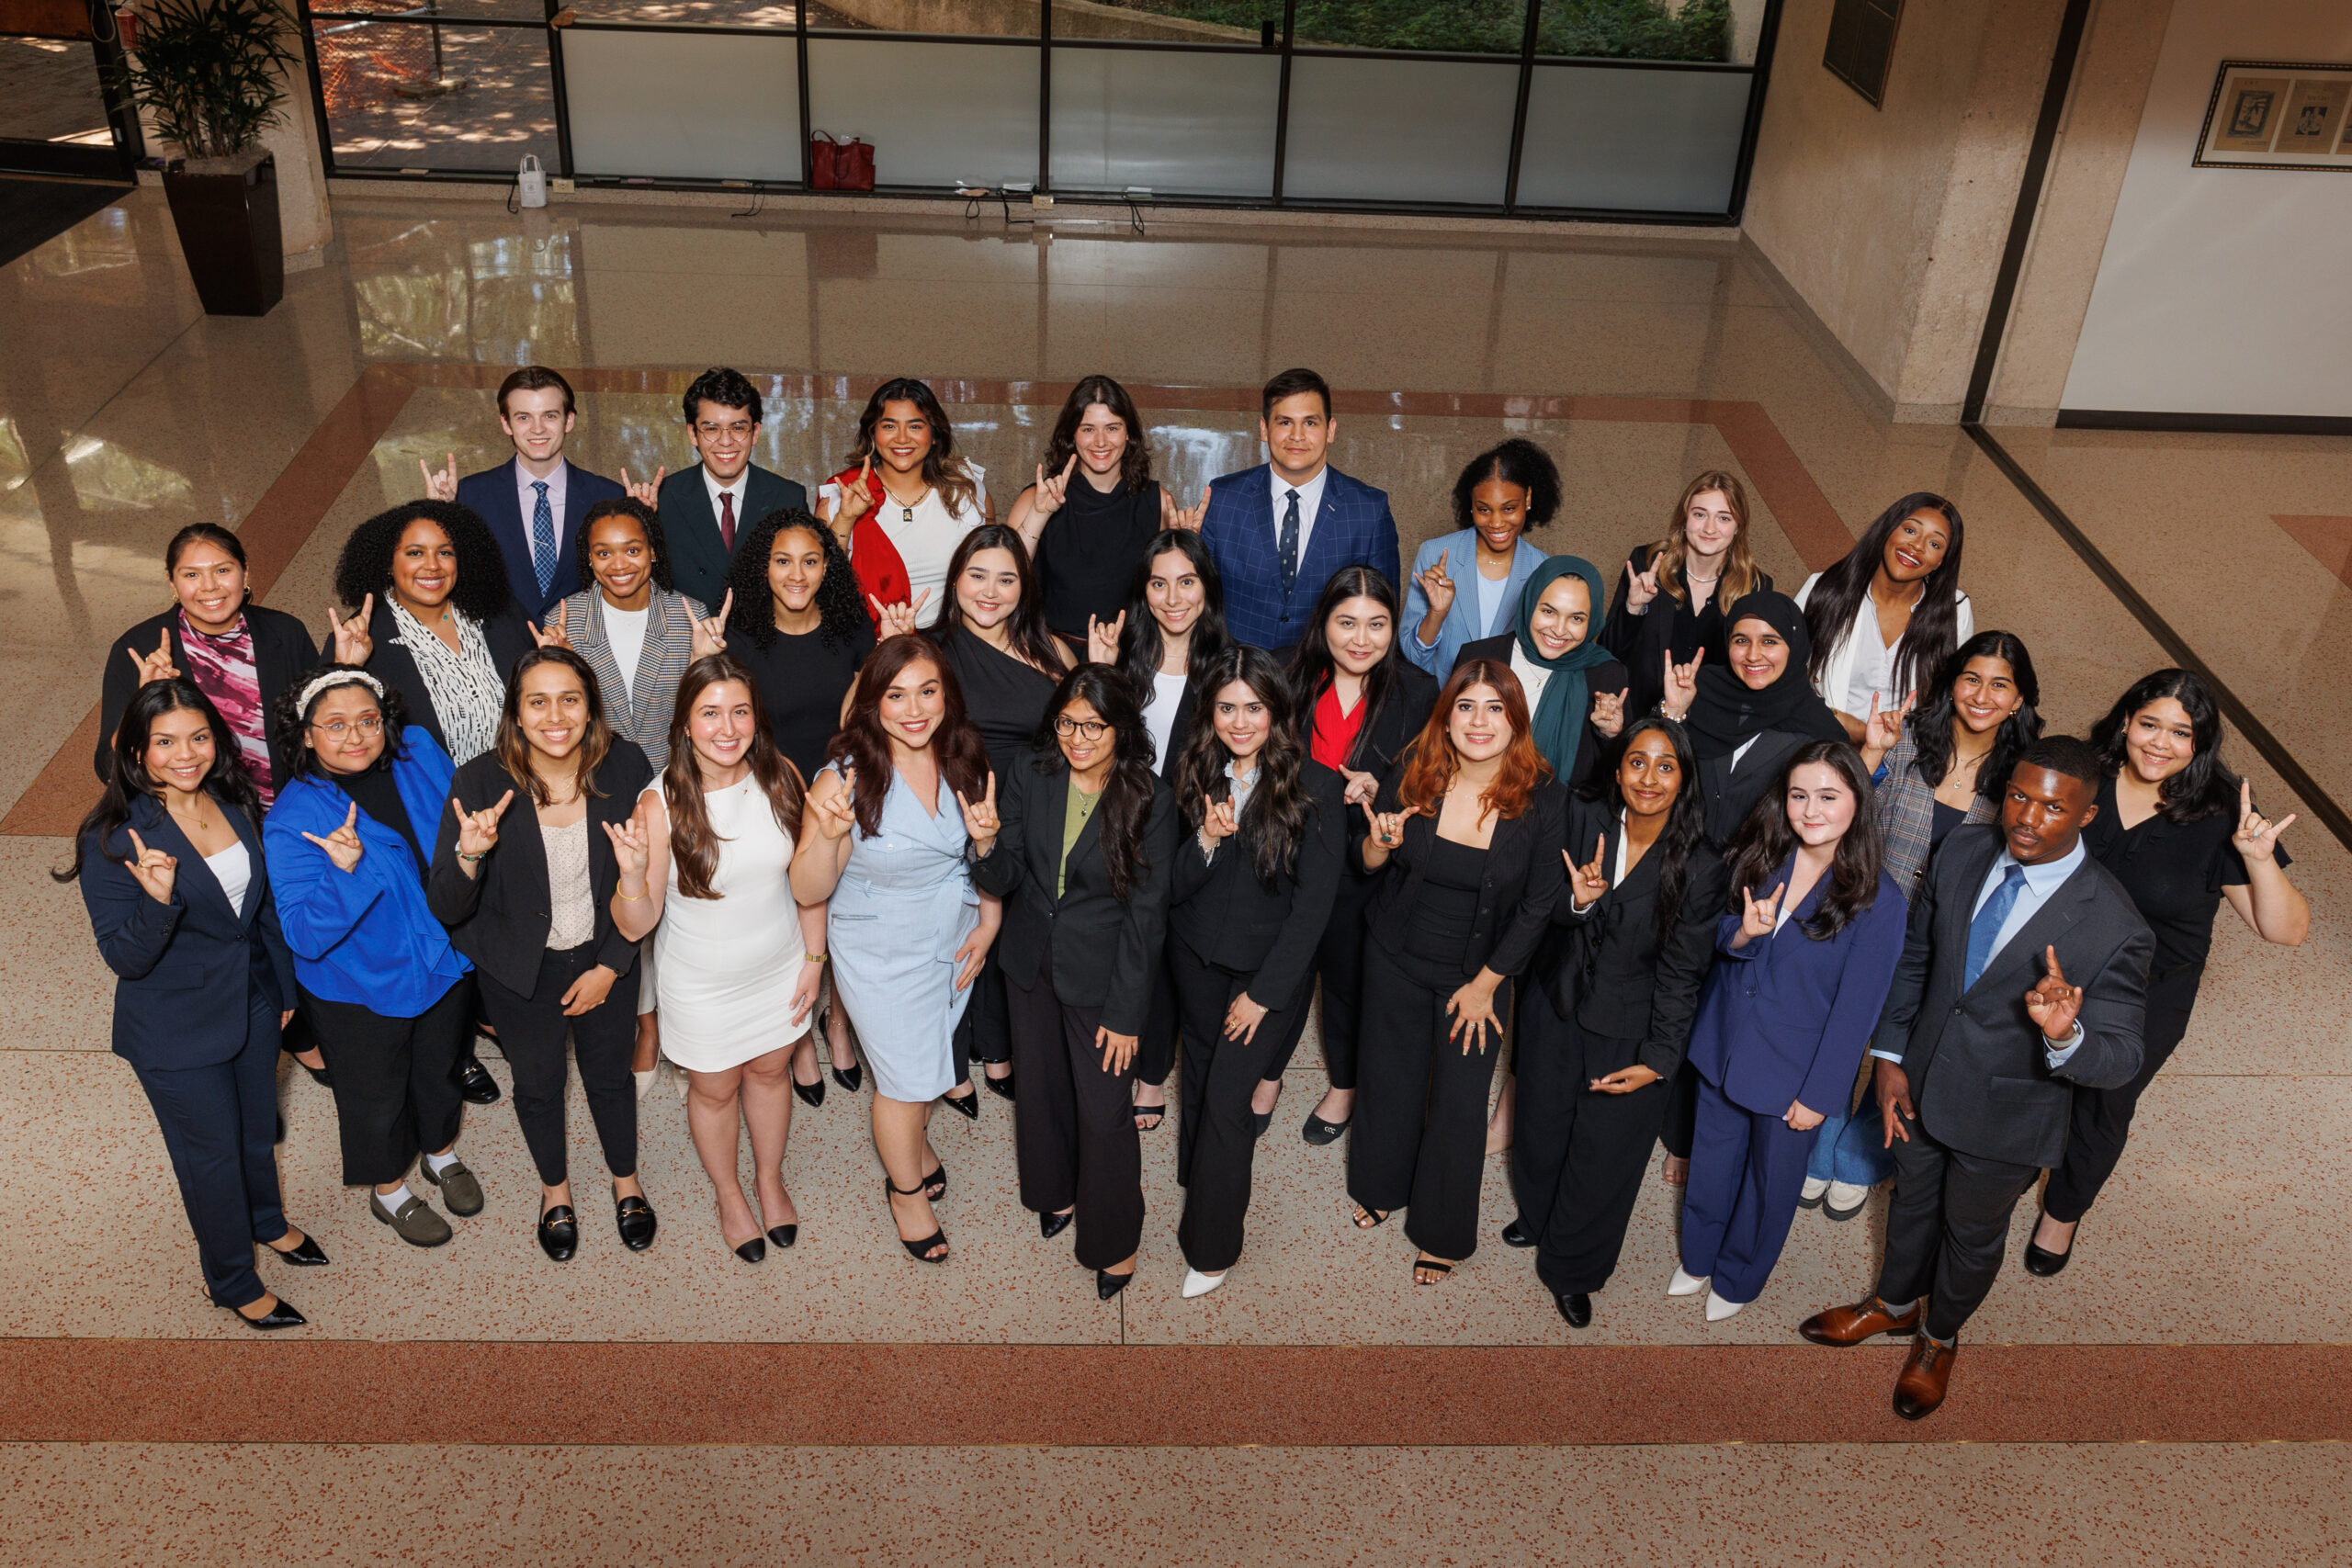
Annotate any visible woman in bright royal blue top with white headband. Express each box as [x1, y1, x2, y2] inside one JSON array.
[[261, 665, 482, 1246]]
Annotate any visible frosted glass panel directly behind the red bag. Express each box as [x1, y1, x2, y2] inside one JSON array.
[[809, 38, 1037, 186]]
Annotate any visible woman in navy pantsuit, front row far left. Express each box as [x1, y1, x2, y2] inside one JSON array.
[[56, 677, 327, 1328]]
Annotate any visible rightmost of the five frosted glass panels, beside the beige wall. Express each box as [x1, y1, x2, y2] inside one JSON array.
[[1520, 63, 1755, 211]]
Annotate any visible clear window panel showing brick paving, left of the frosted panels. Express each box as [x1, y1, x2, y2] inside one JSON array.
[[312, 21, 555, 169]]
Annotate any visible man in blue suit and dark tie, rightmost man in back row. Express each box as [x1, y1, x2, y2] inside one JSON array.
[[1200, 369, 1397, 656]]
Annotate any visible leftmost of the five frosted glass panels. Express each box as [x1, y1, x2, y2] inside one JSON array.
[[564, 26, 799, 181]]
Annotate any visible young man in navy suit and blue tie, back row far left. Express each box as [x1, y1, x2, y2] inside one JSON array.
[[425, 365, 628, 626]]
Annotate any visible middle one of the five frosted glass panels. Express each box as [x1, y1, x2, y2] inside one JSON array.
[[1054, 50, 1282, 195]]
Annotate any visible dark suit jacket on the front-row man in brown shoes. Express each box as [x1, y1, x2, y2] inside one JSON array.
[[1870, 823, 2157, 1166]]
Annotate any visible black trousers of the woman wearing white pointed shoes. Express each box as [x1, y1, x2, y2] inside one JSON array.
[[1169, 942, 1303, 1274]]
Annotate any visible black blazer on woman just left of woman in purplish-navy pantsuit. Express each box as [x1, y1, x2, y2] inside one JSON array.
[[1529, 799, 1731, 1079]]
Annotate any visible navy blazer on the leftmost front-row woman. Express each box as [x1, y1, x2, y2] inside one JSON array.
[[83, 799, 294, 1069]]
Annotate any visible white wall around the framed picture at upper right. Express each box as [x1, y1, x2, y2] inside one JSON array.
[[2063, 0, 2352, 416]]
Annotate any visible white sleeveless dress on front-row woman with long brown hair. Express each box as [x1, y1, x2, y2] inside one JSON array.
[[647, 776, 814, 1072]]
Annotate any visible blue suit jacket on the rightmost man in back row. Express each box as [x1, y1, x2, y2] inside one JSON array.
[[1200, 463, 1404, 649]]
